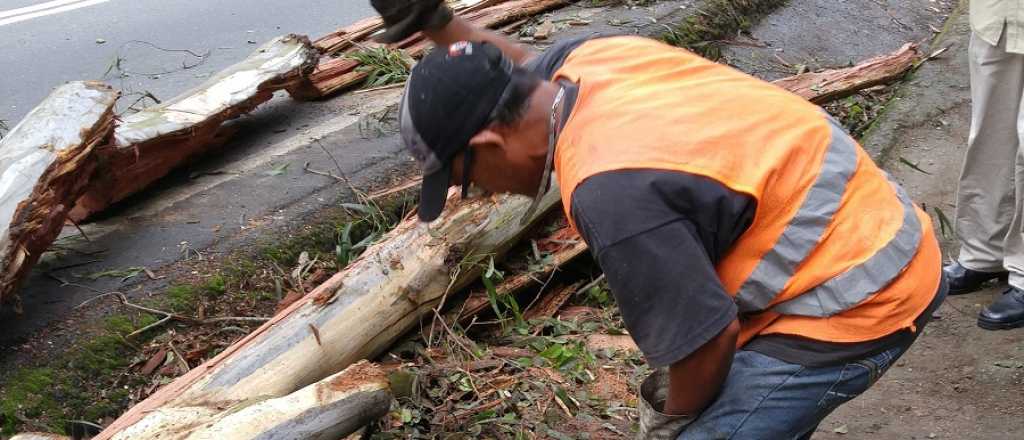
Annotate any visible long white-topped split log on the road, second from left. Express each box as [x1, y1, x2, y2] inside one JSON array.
[[72, 35, 318, 220]]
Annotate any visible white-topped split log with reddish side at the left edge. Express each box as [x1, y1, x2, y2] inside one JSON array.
[[0, 82, 118, 301]]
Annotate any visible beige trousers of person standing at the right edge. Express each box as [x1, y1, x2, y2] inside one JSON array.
[[956, 30, 1024, 289]]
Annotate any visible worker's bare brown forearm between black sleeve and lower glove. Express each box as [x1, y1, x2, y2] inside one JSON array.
[[664, 320, 739, 415]]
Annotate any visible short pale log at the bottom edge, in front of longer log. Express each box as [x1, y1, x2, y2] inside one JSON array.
[[107, 360, 391, 440]]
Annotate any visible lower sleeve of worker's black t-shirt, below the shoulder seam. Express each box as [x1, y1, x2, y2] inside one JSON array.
[[581, 214, 736, 367]]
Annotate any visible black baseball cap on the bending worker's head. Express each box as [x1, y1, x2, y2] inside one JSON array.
[[398, 41, 515, 222]]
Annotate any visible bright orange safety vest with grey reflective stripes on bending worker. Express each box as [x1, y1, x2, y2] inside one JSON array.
[[554, 37, 941, 346]]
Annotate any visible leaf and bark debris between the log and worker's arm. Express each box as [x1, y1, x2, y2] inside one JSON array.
[[371, 213, 648, 439]]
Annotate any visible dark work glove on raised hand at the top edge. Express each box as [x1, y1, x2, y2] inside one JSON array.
[[370, 0, 452, 43]]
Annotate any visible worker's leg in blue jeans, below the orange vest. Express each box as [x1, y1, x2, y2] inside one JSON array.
[[679, 345, 909, 440]]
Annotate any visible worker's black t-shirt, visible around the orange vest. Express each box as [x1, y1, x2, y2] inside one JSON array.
[[526, 37, 941, 367]]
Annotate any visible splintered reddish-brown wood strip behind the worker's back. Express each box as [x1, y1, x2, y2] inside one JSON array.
[[774, 43, 921, 104]]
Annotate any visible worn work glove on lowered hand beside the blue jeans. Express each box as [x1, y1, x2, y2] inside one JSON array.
[[637, 368, 696, 440]]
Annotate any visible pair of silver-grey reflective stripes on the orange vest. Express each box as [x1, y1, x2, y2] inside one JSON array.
[[736, 117, 921, 317]]
